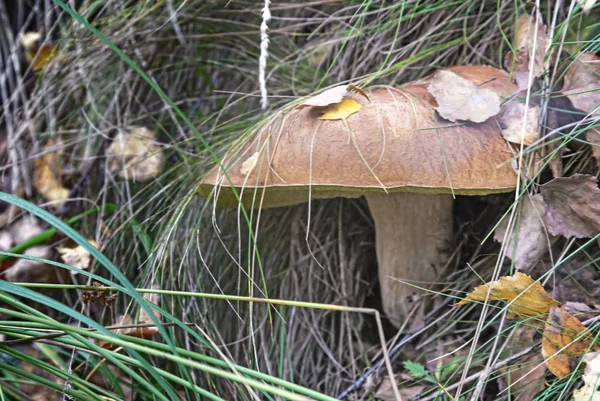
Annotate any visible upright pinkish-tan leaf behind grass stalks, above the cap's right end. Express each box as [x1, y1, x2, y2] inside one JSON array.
[[504, 13, 552, 90]]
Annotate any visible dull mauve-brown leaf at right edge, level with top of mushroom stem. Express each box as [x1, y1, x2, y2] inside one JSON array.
[[540, 174, 600, 238]]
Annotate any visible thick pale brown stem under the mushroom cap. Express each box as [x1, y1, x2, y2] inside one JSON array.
[[366, 192, 453, 327]]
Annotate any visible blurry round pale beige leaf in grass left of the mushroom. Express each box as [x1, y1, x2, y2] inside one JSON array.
[[106, 127, 164, 182]]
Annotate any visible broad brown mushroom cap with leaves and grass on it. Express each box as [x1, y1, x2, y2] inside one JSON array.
[[199, 67, 516, 208]]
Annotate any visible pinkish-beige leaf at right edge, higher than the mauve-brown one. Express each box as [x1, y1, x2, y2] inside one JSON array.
[[562, 53, 600, 115]]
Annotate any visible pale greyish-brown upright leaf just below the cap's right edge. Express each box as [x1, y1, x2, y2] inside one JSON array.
[[494, 194, 548, 272]]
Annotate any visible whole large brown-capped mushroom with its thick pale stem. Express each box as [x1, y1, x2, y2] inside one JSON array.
[[199, 67, 517, 326]]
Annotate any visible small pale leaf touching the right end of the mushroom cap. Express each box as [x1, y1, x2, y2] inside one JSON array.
[[498, 100, 540, 145]]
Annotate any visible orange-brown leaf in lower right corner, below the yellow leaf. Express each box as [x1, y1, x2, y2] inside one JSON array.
[[542, 307, 594, 378]]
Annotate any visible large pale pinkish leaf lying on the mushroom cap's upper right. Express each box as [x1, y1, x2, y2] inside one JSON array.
[[427, 70, 500, 123]]
